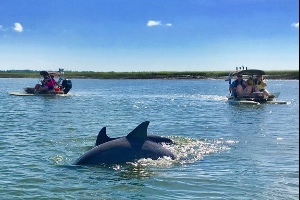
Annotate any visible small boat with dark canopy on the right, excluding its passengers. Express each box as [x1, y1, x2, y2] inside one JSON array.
[[225, 67, 287, 105]]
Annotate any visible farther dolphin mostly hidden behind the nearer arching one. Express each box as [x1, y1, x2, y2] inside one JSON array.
[[95, 127, 174, 146]]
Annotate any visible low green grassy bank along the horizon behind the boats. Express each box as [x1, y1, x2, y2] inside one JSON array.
[[0, 70, 299, 80]]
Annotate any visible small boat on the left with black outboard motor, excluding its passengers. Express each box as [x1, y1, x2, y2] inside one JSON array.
[[9, 69, 72, 96]]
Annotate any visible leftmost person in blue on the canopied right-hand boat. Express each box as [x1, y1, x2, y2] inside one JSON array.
[[229, 74, 252, 97]]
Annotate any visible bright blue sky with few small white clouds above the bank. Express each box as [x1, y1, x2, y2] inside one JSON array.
[[0, 0, 299, 72]]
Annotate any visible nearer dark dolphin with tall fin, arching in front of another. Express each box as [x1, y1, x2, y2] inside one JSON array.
[[74, 121, 175, 165]]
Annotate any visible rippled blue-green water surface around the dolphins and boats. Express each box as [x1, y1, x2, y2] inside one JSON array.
[[0, 79, 299, 199]]
